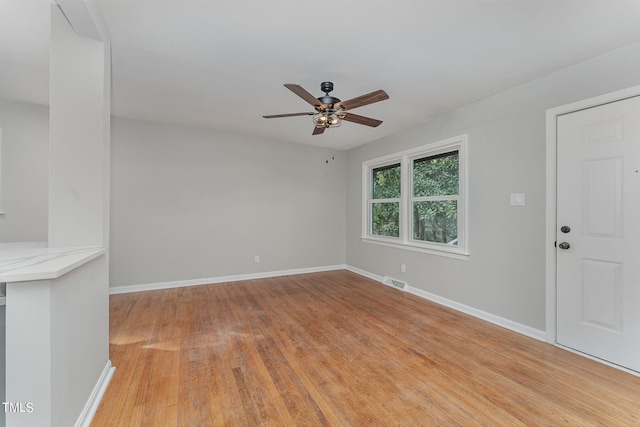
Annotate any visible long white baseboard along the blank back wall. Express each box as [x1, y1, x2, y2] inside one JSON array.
[[109, 264, 346, 295]]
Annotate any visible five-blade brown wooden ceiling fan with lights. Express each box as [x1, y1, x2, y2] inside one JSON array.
[[262, 82, 389, 135]]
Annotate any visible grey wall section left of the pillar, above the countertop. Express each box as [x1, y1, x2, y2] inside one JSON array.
[[0, 99, 49, 243]]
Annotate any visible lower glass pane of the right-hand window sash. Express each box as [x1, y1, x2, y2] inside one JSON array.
[[413, 200, 458, 245]]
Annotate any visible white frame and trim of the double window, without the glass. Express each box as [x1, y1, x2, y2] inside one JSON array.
[[361, 134, 469, 259]]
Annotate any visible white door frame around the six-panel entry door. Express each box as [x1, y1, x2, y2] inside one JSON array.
[[545, 85, 640, 352]]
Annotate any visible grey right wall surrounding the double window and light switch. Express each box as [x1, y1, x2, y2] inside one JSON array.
[[346, 39, 640, 331]]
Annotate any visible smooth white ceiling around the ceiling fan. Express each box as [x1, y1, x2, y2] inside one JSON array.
[[0, 0, 640, 149]]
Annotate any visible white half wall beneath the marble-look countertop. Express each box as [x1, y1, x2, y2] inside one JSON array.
[[6, 254, 110, 427]]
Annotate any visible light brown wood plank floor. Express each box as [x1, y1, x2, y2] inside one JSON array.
[[92, 271, 640, 427]]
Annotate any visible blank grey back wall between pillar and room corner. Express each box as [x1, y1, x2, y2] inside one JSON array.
[[110, 118, 346, 287]]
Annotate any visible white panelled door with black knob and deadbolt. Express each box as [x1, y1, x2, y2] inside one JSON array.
[[556, 97, 640, 371]]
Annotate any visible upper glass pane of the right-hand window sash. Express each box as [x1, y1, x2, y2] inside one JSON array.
[[413, 151, 458, 197]]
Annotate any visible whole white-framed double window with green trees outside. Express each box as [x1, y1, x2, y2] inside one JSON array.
[[362, 135, 468, 258]]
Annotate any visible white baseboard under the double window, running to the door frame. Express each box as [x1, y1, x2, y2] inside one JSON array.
[[345, 265, 546, 341]]
